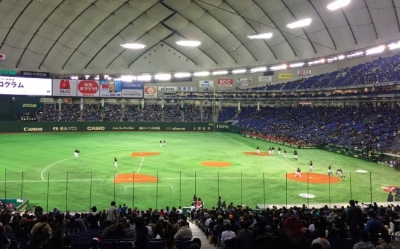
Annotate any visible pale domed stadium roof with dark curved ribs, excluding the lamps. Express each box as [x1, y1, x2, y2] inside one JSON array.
[[0, 0, 400, 74]]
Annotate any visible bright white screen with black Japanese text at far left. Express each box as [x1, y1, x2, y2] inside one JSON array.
[[0, 76, 52, 96]]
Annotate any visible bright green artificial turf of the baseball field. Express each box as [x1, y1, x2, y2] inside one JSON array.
[[0, 132, 399, 211]]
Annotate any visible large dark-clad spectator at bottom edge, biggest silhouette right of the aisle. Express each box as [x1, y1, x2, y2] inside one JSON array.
[[267, 217, 310, 249]]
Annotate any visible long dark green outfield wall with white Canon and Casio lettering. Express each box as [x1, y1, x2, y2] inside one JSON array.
[[0, 122, 242, 133]]
